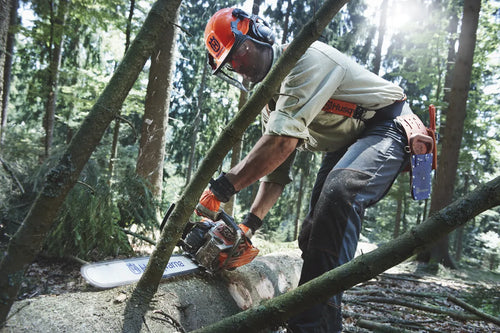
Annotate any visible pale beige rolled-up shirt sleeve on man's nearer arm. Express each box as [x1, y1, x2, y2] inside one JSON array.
[[265, 47, 346, 143]]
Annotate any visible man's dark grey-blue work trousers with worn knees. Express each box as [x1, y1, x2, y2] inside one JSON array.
[[288, 113, 411, 333]]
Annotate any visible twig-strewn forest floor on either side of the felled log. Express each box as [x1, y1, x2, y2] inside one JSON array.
[[5, 240, 500, 332]]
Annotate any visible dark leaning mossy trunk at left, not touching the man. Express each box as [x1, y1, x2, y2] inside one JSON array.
[[0, 0, 184, 323]]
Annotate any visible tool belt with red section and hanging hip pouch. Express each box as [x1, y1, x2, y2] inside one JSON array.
[[322, 96, 437, 200]]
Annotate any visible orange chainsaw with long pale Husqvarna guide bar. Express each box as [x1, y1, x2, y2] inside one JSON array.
[[80, 205, 259, 288]]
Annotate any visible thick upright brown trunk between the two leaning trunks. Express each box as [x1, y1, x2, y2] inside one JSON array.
[[136, 4, 178, 199]]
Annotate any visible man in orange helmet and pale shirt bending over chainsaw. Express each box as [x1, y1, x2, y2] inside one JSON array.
[[200, 8, 428, 333]]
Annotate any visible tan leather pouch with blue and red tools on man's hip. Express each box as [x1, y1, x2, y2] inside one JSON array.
[[396, 105, 437, 200]]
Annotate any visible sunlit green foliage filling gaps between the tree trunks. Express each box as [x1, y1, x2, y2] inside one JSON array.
[[0, 0, 500, 265]]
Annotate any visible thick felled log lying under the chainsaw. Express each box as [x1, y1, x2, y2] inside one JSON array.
[[0, 251, 302, 333]]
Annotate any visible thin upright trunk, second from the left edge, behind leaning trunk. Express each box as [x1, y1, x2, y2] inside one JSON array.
[[43, 0, 68, 159]]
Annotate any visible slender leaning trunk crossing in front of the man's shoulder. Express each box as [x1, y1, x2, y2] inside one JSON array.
[[124, 0, 348, 332]]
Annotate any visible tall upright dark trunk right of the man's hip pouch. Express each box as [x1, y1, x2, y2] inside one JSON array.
[[419, 0, 481, 268]]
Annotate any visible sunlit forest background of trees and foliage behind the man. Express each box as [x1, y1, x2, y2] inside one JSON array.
[[0, 0, 500, 288]]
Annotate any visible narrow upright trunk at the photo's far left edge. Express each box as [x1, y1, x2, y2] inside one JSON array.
[[0, 0, 19, 150]]
